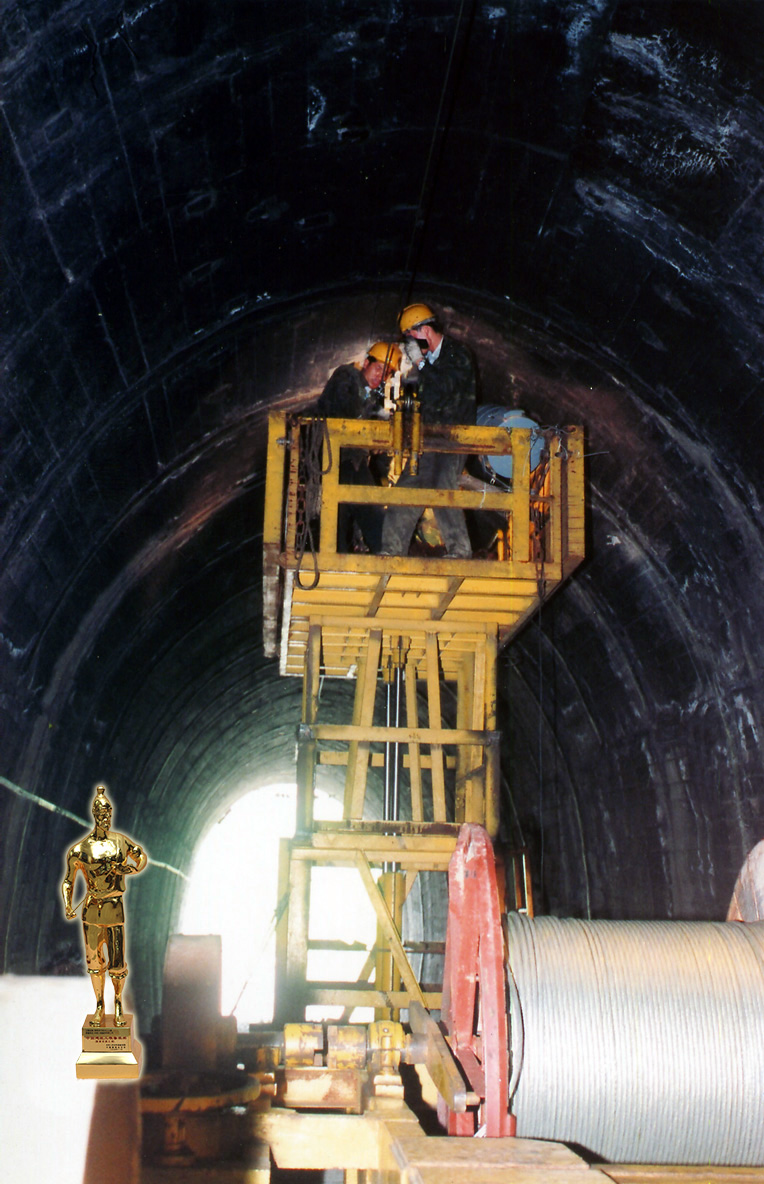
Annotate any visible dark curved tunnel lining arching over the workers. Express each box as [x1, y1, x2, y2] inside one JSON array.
[[0, 0, 764, 1018]]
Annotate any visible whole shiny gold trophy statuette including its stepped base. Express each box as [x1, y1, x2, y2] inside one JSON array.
[[62, 785, 148, 1079]]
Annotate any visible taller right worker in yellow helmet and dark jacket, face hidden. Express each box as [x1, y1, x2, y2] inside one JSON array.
[[381, 304, 477, 559]]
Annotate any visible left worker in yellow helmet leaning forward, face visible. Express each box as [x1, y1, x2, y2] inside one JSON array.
[[316, 341, 403, 552]]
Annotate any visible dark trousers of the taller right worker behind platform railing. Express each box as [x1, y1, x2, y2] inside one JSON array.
[[381, 452, 473, 559]]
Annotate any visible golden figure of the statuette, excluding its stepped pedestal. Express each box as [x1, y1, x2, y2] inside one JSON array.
[[62, 785, 147, 1028]]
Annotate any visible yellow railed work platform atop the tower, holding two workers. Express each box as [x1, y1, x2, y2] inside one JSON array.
[[263, 413, 584, 680]]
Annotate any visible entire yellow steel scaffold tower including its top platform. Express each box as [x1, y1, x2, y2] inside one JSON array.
[[263, 413, 584, 1019]]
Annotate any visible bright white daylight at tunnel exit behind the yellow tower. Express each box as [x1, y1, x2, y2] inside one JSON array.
[[180, 784, 375, 1031]]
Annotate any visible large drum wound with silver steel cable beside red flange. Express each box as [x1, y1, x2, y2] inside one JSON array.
[[506, 913, 764, 1166]]
